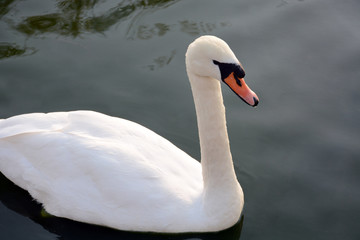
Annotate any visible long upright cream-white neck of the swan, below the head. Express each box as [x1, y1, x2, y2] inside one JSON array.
[[188, 72, 243, 221]]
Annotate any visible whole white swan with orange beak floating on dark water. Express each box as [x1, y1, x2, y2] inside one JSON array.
[[0, 36, 258, 232]]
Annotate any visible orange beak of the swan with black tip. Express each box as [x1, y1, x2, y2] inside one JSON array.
[[223, 72, 259, 107]]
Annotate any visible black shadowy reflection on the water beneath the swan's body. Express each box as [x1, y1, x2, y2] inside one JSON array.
[[0, 173, 244, 240]]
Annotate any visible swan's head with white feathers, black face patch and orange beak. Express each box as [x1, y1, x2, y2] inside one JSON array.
[[186, 36, 259, 107]]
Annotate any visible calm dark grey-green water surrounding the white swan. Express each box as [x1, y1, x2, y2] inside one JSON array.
[[0, 0, 360, 240]]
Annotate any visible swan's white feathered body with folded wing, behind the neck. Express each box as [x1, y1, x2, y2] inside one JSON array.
[[0, 111, 202, 230]]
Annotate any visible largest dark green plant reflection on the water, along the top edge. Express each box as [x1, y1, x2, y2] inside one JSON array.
[[15, 0, 177, 37]]
